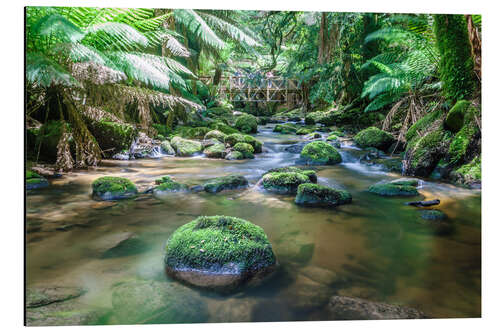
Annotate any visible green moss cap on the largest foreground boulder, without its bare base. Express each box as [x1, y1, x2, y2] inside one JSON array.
[[165, 216, 276, 272]]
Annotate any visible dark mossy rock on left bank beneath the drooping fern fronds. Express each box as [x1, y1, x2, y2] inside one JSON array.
[[89, 121, 138, 153]]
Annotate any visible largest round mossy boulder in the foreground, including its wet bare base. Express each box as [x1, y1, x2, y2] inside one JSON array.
[[165, 216, 277, 292]]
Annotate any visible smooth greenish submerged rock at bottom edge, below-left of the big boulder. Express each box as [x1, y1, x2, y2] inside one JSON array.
[[111, 280, 208, 325]]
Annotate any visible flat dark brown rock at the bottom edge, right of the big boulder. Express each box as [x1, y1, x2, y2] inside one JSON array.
[[327, 296, 428, 320]]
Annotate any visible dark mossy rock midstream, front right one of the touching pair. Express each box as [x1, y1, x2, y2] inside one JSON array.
[[295, 184, 352, 207]]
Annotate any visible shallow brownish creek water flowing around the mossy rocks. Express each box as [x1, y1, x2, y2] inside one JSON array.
[[26, 125, 481, 323]]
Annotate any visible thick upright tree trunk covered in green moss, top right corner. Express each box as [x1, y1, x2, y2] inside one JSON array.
[[434, 14, 475, 102]]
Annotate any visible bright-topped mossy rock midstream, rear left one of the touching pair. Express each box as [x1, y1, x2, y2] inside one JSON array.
[[261, 172, 311, 194]]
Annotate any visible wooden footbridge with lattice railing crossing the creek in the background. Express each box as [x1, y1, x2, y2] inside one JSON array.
[[200, 76, 303, 105]]
